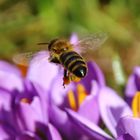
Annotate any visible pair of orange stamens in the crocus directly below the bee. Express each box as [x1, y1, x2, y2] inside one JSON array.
[[67, 84, 87, 111]]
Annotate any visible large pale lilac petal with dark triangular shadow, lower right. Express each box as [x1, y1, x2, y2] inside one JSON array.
[[99, 87, 132, 138]]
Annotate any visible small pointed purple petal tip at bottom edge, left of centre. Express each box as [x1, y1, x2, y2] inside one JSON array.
[[48, 124, 62, 140]]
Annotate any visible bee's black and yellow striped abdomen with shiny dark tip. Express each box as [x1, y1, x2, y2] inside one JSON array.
[[60, 51, 87, 78]]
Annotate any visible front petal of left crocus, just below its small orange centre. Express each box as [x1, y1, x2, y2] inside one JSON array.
[[16, 97, 43, 131]]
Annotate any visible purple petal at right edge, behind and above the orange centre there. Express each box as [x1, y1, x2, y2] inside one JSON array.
[[125, 66, 140, 105]]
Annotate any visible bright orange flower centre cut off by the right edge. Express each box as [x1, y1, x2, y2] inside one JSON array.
[[132, 91, 140, 118]]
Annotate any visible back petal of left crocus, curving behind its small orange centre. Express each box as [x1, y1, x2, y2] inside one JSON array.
[[20, 79, 49, 122]]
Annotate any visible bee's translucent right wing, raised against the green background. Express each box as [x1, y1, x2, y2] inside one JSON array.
[[74, 33, 107, 54]]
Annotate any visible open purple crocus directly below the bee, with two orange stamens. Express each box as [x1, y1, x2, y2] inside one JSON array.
[[27, 34, 105, 139]]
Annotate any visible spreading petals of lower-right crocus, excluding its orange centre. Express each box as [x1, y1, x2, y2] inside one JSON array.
[[67, 87, 140, 140]]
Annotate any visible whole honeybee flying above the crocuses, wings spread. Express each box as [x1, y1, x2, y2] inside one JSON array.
[[14, 33, 107, 86]]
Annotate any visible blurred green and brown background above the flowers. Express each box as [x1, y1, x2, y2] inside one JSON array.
[[0, 0, 140, 91]]
